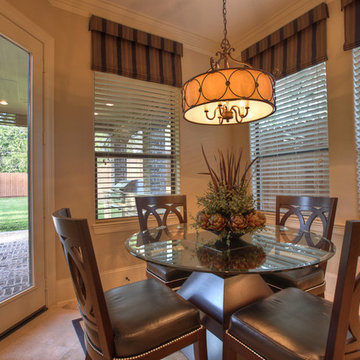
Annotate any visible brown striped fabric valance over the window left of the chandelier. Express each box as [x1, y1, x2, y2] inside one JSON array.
[[89, 15, 183, 87]]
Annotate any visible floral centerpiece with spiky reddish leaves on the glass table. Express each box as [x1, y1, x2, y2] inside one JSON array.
[[196, 147, 266, 241]]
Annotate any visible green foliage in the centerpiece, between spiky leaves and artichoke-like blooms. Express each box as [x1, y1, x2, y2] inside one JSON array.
[[198, 182, 254, 218]]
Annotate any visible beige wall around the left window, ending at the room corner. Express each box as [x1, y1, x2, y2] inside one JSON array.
[[7, 0, 231, 301]]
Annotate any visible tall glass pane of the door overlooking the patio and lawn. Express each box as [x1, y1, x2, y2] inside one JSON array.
[[0, 36, 32, 302]]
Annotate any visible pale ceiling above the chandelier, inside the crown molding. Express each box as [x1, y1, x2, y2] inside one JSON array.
[[103, 0, 296, 42]]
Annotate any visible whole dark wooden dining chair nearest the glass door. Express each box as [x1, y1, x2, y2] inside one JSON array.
[[52, 209, 207, 360]]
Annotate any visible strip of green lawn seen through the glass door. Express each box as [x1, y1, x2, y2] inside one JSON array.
[[0, 197, 29, 231]]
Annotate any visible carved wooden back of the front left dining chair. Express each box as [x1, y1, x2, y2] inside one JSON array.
[[52, 208, 114, 359]]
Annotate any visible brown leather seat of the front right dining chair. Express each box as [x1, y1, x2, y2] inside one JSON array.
[[228, 288, 332, 360]]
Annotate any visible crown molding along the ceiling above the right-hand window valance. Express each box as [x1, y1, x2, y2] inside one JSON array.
[[234, 0, 324, 51]]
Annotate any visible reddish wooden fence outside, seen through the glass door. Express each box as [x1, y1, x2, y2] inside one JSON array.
[[0, 173, 28, 197]]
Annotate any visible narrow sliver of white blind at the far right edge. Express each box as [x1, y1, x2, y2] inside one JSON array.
[[353, 47, 360, 209]]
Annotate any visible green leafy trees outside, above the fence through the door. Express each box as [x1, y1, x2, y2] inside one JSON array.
[[0, 125, 28, 173]]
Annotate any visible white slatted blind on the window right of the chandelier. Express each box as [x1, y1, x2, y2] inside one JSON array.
[[250, 63, 329, 211]]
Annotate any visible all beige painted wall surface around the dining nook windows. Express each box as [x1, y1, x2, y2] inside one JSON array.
[[7, 0, 358, 300]]
